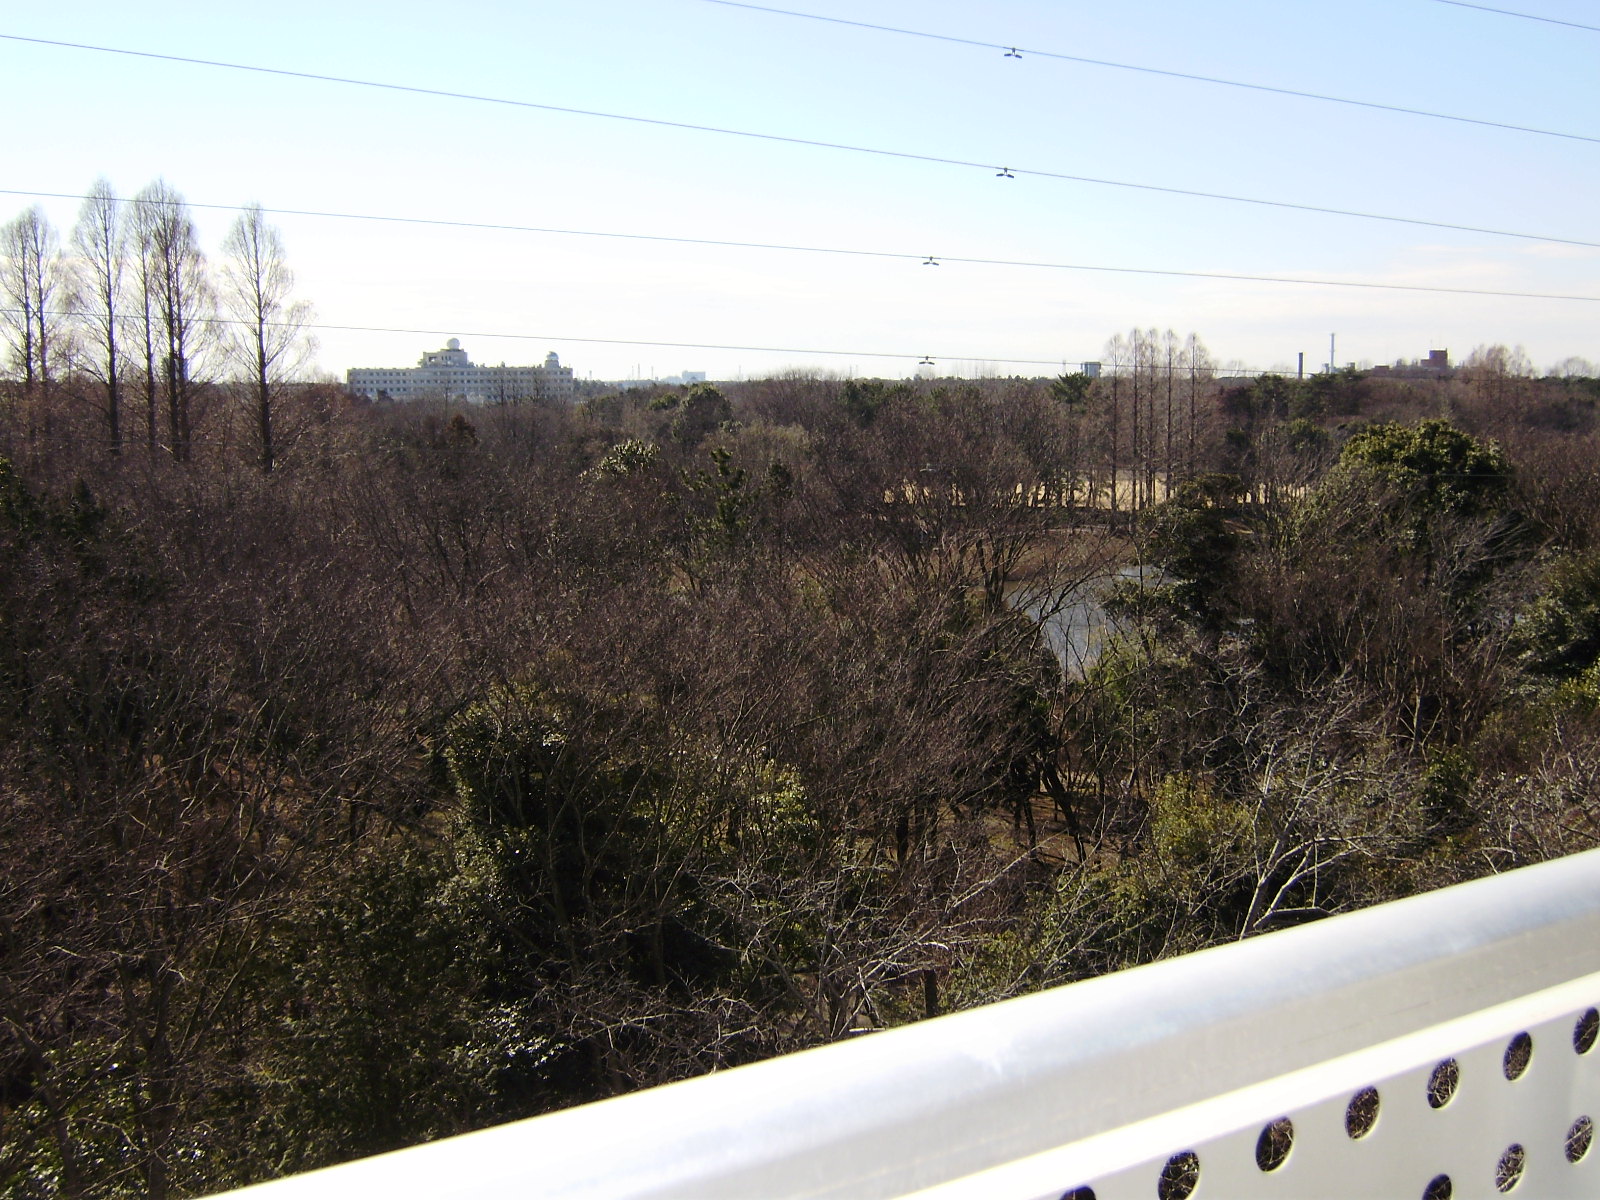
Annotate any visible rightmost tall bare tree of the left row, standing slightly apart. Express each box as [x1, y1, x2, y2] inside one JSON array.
[[222, 205, 314, 470]]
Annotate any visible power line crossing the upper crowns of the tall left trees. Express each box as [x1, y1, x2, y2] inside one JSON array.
[[0, 187, 1600, 304]]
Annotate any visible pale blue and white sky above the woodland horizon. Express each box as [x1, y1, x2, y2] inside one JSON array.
[[0, 0, 1600, 379]]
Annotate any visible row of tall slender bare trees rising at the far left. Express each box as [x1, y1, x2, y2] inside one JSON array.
[[0, 179, 314, 470]]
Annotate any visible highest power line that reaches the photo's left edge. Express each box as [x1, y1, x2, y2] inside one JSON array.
[[0, 34, 1600, 250]]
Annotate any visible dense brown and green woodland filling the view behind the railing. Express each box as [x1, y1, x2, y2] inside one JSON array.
[[0, 338, 1600, 1197]]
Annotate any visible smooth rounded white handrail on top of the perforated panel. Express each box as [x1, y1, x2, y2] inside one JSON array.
[[212, 851, 1600, 1200]]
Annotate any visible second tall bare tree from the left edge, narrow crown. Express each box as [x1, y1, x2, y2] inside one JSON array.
[[72, 178, 128, 454]]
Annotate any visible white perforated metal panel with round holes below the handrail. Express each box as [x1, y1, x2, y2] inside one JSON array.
[[917, 976, 1600, 1200]]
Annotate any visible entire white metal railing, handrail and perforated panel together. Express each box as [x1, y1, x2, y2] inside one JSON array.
[[219, 851, 1600, 1200]]
